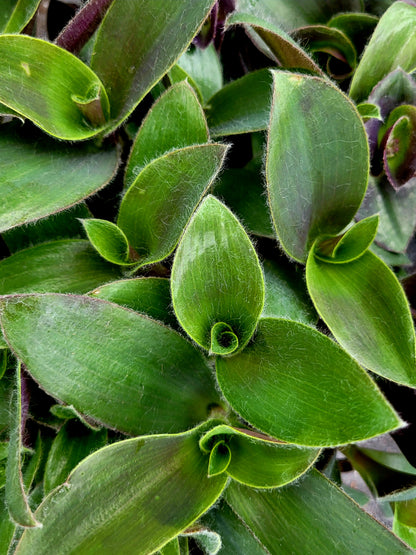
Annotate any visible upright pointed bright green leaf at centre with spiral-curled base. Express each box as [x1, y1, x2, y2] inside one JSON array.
[[171, 196, 264, 354]]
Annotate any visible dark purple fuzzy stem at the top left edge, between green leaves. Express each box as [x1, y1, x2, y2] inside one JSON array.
[[55, 0, 113, 54]]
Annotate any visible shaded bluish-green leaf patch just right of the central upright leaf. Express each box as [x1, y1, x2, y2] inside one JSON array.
[[261, 257, 318, 326]]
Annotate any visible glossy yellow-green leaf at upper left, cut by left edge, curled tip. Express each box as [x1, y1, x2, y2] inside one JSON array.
[[0, 35, 109, 141]]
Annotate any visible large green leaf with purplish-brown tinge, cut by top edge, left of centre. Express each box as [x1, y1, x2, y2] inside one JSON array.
[[90, 0, 214, 132]]
